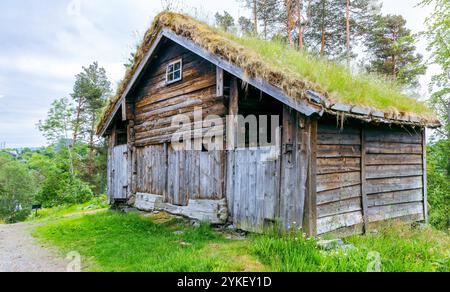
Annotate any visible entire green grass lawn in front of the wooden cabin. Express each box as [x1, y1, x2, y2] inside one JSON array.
[[34, 211, 450, 272]]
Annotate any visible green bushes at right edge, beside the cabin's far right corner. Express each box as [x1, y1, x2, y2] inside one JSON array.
[[427, 140, 450, 231]]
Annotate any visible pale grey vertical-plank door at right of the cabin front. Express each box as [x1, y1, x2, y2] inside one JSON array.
[[227, 146, 281, 232]]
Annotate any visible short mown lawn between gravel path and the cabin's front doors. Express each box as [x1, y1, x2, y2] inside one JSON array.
[[35, 212, 264, 272]]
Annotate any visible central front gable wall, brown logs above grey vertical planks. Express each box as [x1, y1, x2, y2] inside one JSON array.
[[134, 40, 226, 206]]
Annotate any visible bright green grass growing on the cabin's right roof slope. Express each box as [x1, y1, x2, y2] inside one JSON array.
[[222, 33, 430, 114]]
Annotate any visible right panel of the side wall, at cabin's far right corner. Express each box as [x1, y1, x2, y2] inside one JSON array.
[[364, 125, 427, 224]]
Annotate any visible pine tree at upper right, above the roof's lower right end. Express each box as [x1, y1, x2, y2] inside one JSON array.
[[367, 15, 426, 87]]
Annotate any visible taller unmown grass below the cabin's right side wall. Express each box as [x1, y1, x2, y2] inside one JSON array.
[[252, 225, 450, 272]]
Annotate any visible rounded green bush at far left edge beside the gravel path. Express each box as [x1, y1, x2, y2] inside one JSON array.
[[0, 157, 36, 223]]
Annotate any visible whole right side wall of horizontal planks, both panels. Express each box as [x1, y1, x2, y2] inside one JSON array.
[[316, 119, 426, 234]]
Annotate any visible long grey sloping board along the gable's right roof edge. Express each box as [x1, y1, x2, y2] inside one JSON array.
[[162, 28, 323, 117]]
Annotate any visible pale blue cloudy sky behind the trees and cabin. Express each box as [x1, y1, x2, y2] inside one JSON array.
[[0, 0, 436, 148]]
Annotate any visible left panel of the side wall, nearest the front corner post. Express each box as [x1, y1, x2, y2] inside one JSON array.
[[317, 120, 364, 234]]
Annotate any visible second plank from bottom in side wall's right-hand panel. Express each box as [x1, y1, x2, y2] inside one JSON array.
[[368, 189, 423, 207]]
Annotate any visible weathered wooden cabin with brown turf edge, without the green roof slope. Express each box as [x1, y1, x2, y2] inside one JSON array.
[[98, 13, 438, 235]]
